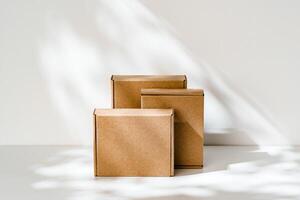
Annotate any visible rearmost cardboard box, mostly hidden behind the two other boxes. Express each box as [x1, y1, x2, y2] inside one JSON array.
[[111, 75, 187, 108]]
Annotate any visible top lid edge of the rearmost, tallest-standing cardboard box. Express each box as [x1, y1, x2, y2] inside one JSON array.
[[111, 75, 186, 81]]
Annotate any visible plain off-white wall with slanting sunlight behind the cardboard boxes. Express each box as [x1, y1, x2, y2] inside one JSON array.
[[0, 0, 300, 145]]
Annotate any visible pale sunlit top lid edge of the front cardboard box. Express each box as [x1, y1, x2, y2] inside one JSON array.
[[94, 108, 173, 116]]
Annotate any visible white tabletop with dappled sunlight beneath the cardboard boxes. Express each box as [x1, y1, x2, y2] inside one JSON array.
[[0, 146, 300, 200]]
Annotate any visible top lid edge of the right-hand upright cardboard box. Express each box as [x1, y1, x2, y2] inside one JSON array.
[[141, 89, 204, 96]]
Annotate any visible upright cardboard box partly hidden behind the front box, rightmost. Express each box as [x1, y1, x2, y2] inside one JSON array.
[[141, 89, 204, 168]]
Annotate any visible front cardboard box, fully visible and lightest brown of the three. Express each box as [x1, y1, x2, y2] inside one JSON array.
[[94, 109, 174, 176]]
